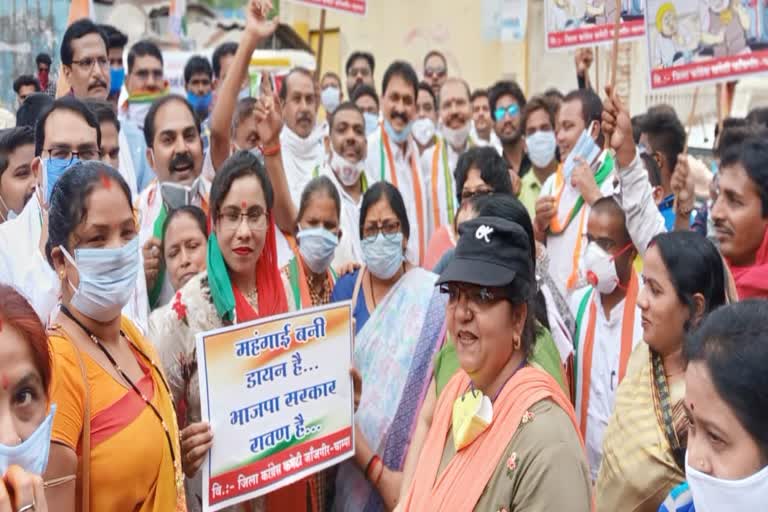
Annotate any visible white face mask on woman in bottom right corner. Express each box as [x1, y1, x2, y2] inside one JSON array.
[[685, 453, 768, 512]]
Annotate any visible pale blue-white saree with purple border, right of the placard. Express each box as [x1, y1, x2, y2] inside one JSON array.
[[335, 268, 447, 512]]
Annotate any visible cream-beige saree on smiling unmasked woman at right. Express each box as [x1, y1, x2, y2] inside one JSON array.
[[596, 343, 687, 512]]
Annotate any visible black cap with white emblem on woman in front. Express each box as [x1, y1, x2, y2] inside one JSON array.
[[437, 217, 534, 287]]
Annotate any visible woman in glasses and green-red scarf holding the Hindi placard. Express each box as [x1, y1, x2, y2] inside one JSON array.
[[150, 151, 328, 511]]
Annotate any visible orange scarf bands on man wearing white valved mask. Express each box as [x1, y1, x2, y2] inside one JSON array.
[[573, 271, 638, 437]]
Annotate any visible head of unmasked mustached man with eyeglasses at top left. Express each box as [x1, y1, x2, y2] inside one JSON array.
[[61, 18, 110, 100]]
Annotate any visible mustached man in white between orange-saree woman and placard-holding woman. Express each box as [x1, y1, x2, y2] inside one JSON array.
[[136, 95, 211, 308]]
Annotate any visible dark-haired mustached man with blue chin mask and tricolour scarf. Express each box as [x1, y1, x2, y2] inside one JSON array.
[[365, 61, 430, 265]]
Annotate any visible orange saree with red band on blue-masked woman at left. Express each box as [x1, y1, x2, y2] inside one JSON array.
[[49, 317, 187, 512]]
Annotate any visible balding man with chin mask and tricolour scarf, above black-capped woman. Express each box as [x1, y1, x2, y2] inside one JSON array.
[[421, 78, 472, 240]]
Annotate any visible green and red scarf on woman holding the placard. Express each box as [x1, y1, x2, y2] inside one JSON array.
[[207, 213, 288, 324]]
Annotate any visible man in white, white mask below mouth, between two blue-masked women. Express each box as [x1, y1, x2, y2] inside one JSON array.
[[320, 102, 367, 267]]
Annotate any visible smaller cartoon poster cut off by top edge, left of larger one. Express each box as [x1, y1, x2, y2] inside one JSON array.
[[544, 0, 645, 50]]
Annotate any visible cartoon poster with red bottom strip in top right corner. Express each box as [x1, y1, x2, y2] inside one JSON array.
[[646, 0, 768, 89]]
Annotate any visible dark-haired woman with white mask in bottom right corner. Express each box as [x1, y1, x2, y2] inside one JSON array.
[[659, 300, 768, 512]]
